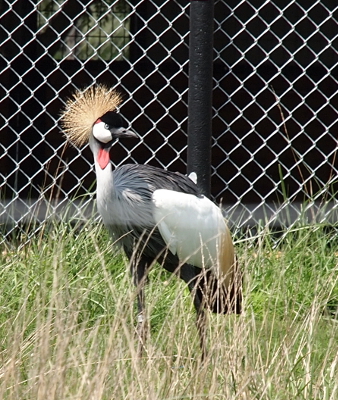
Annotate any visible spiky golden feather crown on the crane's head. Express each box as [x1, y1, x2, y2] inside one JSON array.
[[60, 85, 122, 146]]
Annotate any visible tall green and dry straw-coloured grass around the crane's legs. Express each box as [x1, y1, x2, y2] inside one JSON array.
[[0, 224, 338, 400]]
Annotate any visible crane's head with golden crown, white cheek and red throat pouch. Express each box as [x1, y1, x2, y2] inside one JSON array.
[[61, 85, 137, 169]]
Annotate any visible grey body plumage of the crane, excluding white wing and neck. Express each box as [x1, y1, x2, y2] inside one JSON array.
[[97, 164, 200, 270]]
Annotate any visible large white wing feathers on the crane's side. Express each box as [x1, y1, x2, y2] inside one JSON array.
[[152, 189, 234, 282]]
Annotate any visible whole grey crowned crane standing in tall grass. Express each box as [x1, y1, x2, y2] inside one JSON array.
[[61, 85, 242, 355]]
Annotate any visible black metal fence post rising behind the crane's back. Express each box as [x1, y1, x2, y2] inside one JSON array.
[[188, 0, 214, 197]]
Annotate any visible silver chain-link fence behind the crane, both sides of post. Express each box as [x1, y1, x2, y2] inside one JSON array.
[[0, 0, 338, 239]]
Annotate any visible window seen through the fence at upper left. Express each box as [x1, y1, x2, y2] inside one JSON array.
[[38, 0, 131, 60]]
